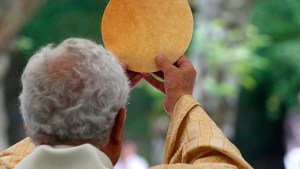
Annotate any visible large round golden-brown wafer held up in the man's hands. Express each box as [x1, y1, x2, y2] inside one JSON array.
[[102, 0, 193, 72]]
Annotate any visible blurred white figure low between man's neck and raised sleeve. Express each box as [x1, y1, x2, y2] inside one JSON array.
[[114, 141, 149, 169]]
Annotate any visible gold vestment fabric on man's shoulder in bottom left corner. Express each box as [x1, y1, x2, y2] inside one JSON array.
[[0, 137, 34, 169]]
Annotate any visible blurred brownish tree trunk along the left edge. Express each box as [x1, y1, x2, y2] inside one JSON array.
[[0, 0, 42, 150]]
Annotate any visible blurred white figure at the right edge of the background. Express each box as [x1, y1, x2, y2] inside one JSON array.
[[284, 91, 300, 169]]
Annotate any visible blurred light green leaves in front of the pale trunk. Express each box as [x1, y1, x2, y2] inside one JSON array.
[[192, 20, 268, 97]]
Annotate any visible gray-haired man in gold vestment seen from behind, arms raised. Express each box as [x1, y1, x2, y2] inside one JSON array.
[[0, 38, 251, 169]]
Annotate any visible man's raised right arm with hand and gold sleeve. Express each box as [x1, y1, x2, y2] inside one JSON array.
[[143, 57, 252, 169]]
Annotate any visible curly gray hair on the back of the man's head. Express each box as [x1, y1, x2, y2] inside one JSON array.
[[19, 38, 130, 146]]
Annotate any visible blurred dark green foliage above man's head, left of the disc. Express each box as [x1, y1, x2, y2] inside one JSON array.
[[22, 0, 108, 57]]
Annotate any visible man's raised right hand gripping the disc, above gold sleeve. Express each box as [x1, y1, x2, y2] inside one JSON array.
[[143, 56, 197, 115]]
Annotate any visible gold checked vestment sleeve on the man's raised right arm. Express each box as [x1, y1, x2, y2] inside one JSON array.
[[151, 95, 252, 169]]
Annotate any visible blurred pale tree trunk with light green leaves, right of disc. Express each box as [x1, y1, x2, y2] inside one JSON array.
[[189, 0, 265, 138]]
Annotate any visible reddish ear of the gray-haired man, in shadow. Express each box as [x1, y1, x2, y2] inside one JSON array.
[[110, 107, 126, 144]]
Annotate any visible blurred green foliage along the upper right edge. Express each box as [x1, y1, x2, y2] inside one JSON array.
[[252, 0, 300, 120]]
